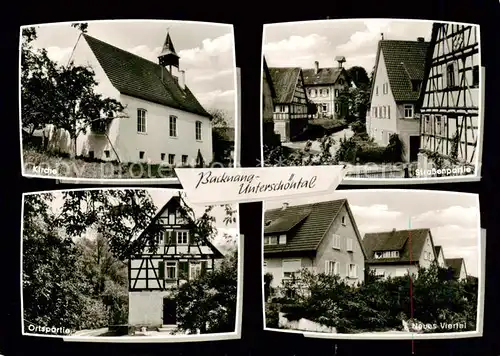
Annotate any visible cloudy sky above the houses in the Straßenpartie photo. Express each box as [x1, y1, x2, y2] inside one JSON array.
[[263, 19, 432, 74]]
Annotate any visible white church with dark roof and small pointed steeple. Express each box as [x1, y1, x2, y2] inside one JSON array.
[[36, 33, 213, 165]]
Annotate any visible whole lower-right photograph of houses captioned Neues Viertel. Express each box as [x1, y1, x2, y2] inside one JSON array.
[[262, 189, 485, 339]]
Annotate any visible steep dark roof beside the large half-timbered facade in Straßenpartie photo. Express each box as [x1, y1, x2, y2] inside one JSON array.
[[370, 40, 430, 102]]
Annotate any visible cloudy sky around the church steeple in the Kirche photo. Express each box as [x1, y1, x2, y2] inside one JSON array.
[[25, 20, 236, 122]]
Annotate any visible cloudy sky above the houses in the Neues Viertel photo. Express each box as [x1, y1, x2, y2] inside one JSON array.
[[265, 189, 480, 277]]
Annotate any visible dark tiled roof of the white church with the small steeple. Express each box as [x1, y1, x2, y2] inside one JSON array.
[[83, 34, 210, 117]]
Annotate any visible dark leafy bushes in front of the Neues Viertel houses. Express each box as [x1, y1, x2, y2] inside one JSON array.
[[272, 265, 478, 333]]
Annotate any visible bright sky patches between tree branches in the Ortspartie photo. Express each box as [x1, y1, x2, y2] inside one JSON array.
[[34, 188, 239, 246]]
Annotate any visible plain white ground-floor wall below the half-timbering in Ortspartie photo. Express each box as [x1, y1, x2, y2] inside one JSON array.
[[128, 291, 170, 326]]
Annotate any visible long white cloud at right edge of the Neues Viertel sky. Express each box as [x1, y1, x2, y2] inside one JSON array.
[[412, 206, 479, 229]]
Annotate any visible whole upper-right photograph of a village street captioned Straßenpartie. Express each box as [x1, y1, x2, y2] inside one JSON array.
[[260, 19, 483, 183]]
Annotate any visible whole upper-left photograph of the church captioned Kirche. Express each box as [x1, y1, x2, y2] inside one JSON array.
[[19, 20, 238, 182]]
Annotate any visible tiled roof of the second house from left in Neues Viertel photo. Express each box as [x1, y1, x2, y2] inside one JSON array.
[[363, 229, 430, 264]]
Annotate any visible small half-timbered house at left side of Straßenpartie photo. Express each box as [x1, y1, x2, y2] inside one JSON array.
[[269, 67, 309, 142]]
